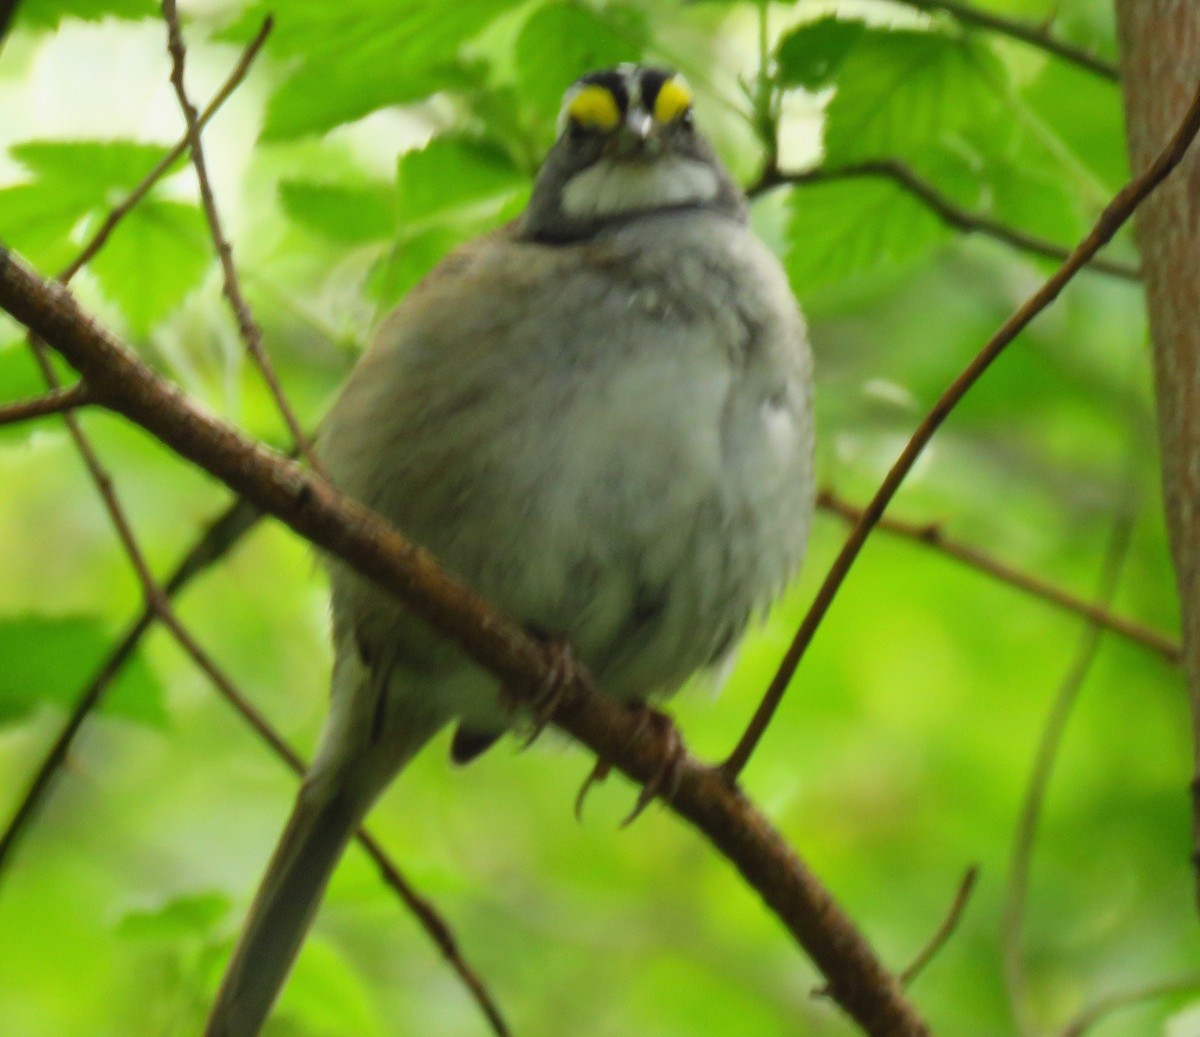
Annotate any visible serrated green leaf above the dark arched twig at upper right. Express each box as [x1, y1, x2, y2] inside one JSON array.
[[824, 30, 1007, 163]]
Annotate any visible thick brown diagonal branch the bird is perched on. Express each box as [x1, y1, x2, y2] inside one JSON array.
[[0, 252, 930, 1037]]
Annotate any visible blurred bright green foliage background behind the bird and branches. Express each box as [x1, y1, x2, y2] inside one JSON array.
[[0, 0, 1200, 1037]]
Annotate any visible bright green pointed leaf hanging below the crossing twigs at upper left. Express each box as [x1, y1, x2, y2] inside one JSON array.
[[91, 198, 212, 336]]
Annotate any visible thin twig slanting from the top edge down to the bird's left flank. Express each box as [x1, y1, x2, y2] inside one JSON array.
[[162, 0, 322, 473]]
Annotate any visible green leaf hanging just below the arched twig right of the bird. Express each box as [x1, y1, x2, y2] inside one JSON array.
[[785, 180, 947, 293]]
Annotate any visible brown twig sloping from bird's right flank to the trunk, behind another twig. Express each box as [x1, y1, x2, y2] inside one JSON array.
[[817, 490, 1182, 665]]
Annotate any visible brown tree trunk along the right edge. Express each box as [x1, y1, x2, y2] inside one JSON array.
[[1116, 0, 1200, 904]]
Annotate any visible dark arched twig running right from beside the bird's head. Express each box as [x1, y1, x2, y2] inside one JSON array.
[[746, 158, 1141, 281]]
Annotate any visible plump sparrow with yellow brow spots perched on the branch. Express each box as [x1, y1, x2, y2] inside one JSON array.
[[205, 65, 814, 1037]]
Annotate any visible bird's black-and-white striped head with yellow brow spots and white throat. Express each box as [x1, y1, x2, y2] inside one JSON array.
[[521, 65, 745, 244]]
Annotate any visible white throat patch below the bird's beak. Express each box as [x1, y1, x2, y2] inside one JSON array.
[[563, 155, 720, 220]]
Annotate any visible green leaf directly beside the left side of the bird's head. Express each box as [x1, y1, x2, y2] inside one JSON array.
[[396, 137, 524, 221]]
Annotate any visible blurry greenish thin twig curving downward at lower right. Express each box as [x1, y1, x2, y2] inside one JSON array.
[[1000, 484, 1136, 1037]]
